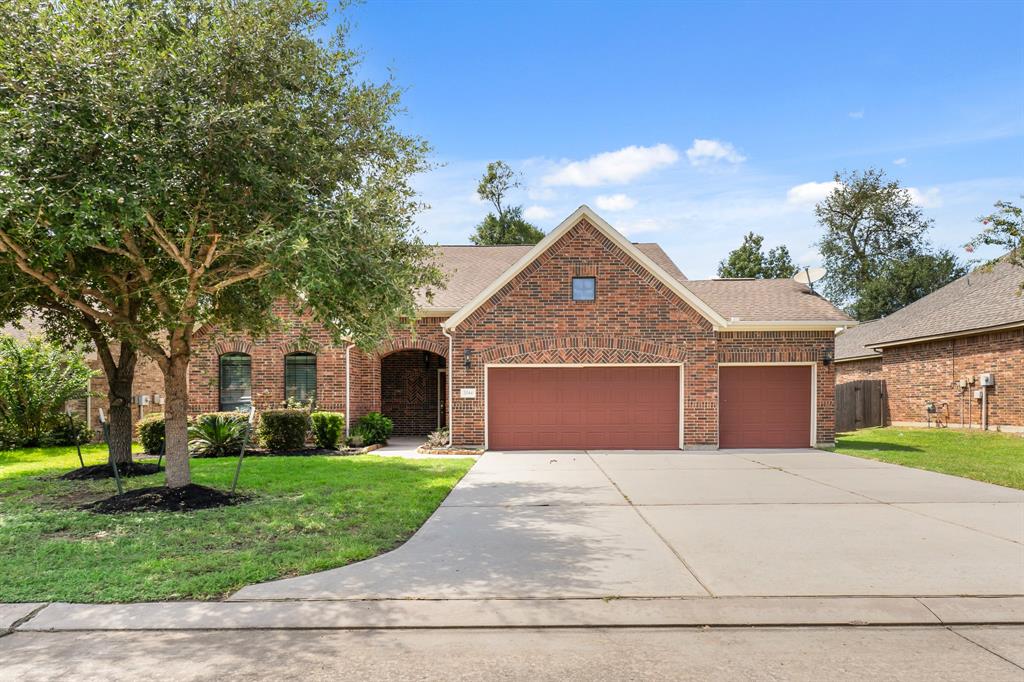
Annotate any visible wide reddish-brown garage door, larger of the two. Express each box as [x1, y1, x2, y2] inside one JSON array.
[[487, 367, 679, 450]]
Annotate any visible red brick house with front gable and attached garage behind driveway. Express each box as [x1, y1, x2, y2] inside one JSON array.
[[189, 206, 853, 450]]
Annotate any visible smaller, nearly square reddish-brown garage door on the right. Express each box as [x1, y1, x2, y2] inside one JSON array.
[[718, 366, 811, 447]]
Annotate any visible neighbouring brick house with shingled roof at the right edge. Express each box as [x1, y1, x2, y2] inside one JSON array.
[[836, 261, 1024, 431]]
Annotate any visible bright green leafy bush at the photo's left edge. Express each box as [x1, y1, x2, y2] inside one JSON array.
[[0, 335, 93, 446]]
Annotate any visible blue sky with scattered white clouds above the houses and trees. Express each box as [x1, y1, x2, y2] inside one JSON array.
[[339, 0, 1024, 278]]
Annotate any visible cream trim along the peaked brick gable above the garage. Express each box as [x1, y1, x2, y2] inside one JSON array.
[[444, 205, 726, 329]]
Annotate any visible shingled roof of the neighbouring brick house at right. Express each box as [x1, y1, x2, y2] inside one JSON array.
[[864, 259, 1024, 347]]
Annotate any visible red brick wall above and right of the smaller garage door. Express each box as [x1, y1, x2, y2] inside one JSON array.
[[718, 332, 836, 444]]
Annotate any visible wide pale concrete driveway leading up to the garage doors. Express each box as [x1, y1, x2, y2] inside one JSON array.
[[232, 450, 1024, 600]]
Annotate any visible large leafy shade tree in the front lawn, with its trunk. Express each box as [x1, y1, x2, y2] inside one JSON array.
[[0, 0, 440, 487]]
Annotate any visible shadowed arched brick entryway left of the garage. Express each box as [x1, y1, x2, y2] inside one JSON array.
[[381, 349, 447, 436]]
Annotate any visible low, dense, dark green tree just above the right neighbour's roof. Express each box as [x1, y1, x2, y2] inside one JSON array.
[[847, 250, 967, 321]]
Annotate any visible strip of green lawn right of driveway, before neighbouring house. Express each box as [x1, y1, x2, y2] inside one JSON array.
[[836, 426, 1024, 489]]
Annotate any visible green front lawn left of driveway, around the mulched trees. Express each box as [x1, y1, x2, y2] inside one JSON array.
[[0, 446, 472, 602]]
